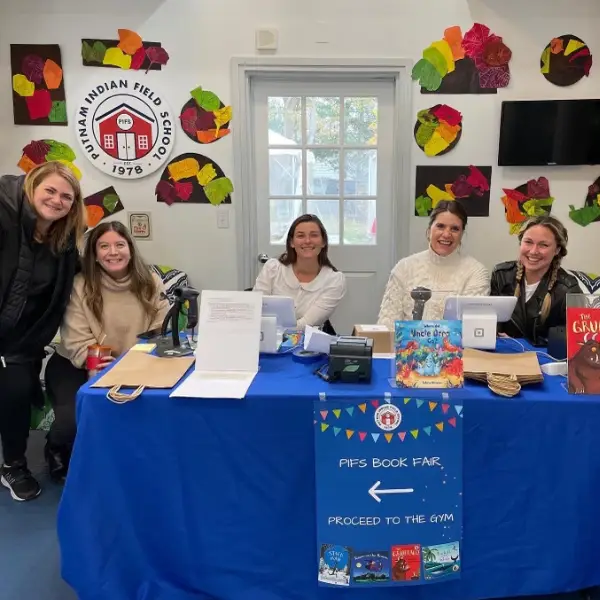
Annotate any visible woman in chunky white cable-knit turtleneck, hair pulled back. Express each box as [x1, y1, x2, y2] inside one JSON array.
[[378, 200, 490, 330]]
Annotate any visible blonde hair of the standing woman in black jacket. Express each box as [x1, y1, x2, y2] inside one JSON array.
[[23, 160, 86, 254]]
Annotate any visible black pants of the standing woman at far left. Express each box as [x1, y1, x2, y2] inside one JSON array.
[[0, 360, 43, 464]]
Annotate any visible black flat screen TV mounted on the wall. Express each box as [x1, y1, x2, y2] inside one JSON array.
[[498, 100, 600, 167]]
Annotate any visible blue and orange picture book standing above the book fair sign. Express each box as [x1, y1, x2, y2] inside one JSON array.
[[395, 320, 464, 389]]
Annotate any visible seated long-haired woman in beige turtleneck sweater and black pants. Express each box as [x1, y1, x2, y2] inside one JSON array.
[[45, 221, 169, 480]]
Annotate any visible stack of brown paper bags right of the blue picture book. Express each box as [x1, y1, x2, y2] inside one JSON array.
[[463, 348, 544, 385]]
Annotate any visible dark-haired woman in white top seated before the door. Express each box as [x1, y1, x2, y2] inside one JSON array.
[[254, 215, 346, 329]]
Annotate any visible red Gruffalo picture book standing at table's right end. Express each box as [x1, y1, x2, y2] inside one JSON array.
[[567, 294, 600, 394]]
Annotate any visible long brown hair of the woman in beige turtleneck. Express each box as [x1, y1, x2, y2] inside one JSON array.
[[82, 221, 158, 323]]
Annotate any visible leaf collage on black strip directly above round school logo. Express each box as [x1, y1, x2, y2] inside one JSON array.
[[81, 29, 169, 73]]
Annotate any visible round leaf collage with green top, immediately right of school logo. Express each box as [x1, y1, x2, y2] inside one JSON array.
[[179, 87, 232, 144]]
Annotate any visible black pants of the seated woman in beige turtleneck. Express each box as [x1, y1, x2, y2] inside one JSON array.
[[44, 352, 88, 448]]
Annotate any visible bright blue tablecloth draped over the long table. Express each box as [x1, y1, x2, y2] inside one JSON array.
[[58, 342, 600, 600]]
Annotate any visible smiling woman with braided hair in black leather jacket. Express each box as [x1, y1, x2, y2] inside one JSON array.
[[491, 216, 581, 346]]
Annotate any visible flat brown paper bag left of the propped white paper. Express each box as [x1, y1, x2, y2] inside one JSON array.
[[91, 350, 194, 389]]
